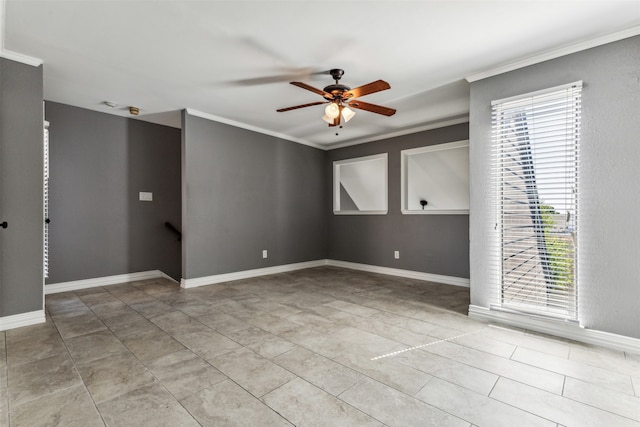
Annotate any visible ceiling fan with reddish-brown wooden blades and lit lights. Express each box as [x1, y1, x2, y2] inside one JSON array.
[[276, 68, 396, 126]]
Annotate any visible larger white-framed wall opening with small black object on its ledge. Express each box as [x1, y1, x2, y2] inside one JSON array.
[[401, 140, 469, 214]]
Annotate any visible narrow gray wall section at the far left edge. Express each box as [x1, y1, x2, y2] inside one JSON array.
[[0, 58, 44, 317]]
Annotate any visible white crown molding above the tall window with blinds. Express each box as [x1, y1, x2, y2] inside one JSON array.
[[465, 25, 640, 83]]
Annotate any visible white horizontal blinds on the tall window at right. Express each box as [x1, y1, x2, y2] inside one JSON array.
[[492, 82, 582, 320]]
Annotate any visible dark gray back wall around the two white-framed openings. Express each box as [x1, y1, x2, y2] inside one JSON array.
[[324, 124, 469, 278]]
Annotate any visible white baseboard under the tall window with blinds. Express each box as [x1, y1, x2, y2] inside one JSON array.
[[469, 305, 640, 354]]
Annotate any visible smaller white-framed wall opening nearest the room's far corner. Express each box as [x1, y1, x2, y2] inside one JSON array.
[[333, 153, 387, 215]]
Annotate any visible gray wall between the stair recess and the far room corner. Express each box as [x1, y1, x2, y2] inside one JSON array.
[[182, 112, 328, 279]]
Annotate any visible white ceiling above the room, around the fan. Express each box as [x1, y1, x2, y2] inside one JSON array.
[[0, 0, 640, 148]]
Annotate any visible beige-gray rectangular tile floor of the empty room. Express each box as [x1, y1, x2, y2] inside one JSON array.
[[0, 267, 640, 427]]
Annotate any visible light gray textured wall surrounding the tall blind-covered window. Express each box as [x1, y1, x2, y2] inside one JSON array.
[[470, 37, 640, 338]]
